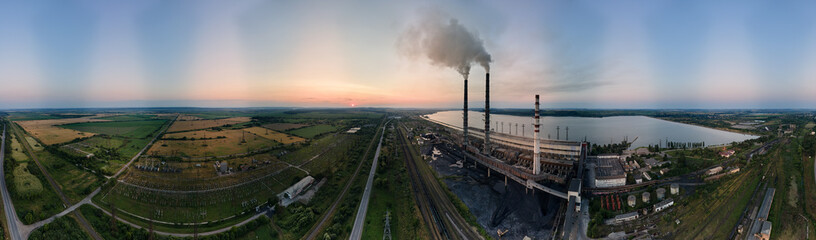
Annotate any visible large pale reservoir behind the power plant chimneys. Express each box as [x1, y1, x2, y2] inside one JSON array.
[[428, 111, 757, 148]]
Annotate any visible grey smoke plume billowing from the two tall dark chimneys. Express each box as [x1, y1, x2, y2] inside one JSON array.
[[397, 13, 492, 79]]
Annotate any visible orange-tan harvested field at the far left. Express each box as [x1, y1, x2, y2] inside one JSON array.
[[15, 114, 112, 145]]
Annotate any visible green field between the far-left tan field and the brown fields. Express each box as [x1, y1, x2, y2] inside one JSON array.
[[60, 120, 167, 138]]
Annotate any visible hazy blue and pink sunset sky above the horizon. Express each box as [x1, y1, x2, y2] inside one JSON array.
[[0, 0, 816, 109]]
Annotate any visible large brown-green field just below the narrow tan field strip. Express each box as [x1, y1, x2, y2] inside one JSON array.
[[148, 128, 279, 157]]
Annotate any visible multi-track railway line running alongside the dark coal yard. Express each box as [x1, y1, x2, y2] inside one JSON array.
[[397, 123, 482, 239]]
